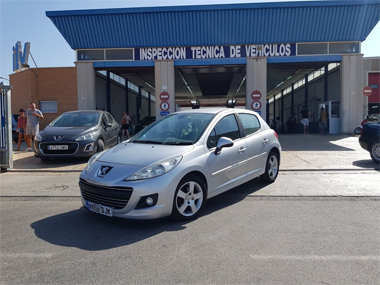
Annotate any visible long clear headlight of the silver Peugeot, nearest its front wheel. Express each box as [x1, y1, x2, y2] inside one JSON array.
[[125, 156, 182, 181]]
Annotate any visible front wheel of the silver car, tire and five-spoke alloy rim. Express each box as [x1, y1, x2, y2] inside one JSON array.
[[171, 174, 207, 221]]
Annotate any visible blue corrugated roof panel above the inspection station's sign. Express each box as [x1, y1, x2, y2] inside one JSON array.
[[46, 0, 380, 49]]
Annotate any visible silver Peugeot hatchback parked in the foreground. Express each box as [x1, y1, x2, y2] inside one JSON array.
[[79, 108, 281, 220]]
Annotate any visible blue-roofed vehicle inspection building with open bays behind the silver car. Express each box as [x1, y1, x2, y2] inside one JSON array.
[[11, 0, 380, 133]]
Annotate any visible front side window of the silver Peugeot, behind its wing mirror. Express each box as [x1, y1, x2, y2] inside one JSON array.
[[207, 115, 240, 148]]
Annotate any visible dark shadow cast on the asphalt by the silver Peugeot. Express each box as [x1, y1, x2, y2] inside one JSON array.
[[30, 179, 266, 251]]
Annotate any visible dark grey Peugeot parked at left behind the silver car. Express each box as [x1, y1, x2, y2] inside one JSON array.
[[34, 110, 121, 160]]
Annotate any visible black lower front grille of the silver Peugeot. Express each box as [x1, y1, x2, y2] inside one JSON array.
[[79, 178, 133, 209]]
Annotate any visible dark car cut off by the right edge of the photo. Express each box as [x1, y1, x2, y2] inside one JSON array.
[[359, 120, 380, 163]]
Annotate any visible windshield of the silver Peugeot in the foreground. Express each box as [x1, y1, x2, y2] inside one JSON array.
[[132, 113, 214, 145]]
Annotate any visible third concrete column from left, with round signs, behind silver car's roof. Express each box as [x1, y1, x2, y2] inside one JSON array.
[[245, 57, 267, 120]]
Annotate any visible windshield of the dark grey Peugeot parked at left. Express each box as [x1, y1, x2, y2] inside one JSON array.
[[49, 112, 99, 127]]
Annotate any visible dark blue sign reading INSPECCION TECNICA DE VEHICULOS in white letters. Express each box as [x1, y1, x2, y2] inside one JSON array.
[[135, 43, 296, 60]]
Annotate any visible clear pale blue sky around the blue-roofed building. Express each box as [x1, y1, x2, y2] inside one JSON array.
[[0, 0, 380, 81]]
